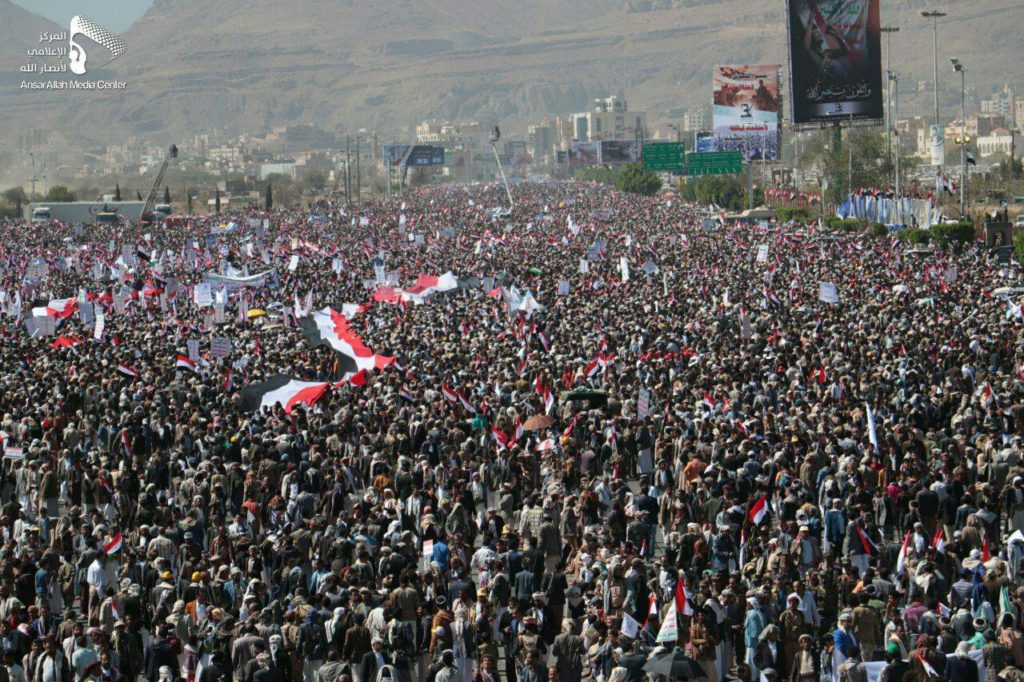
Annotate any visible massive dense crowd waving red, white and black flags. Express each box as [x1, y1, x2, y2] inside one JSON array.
[[0, 183, 1024, 682]]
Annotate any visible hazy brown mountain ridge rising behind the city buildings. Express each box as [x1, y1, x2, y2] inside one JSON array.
[[0, 0, 1024, 142]]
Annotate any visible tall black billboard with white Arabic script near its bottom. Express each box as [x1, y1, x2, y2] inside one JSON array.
[[786, 0, 882, 124]]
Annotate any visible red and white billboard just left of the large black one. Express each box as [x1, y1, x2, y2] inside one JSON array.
[[712, 65, 779, 161]]
